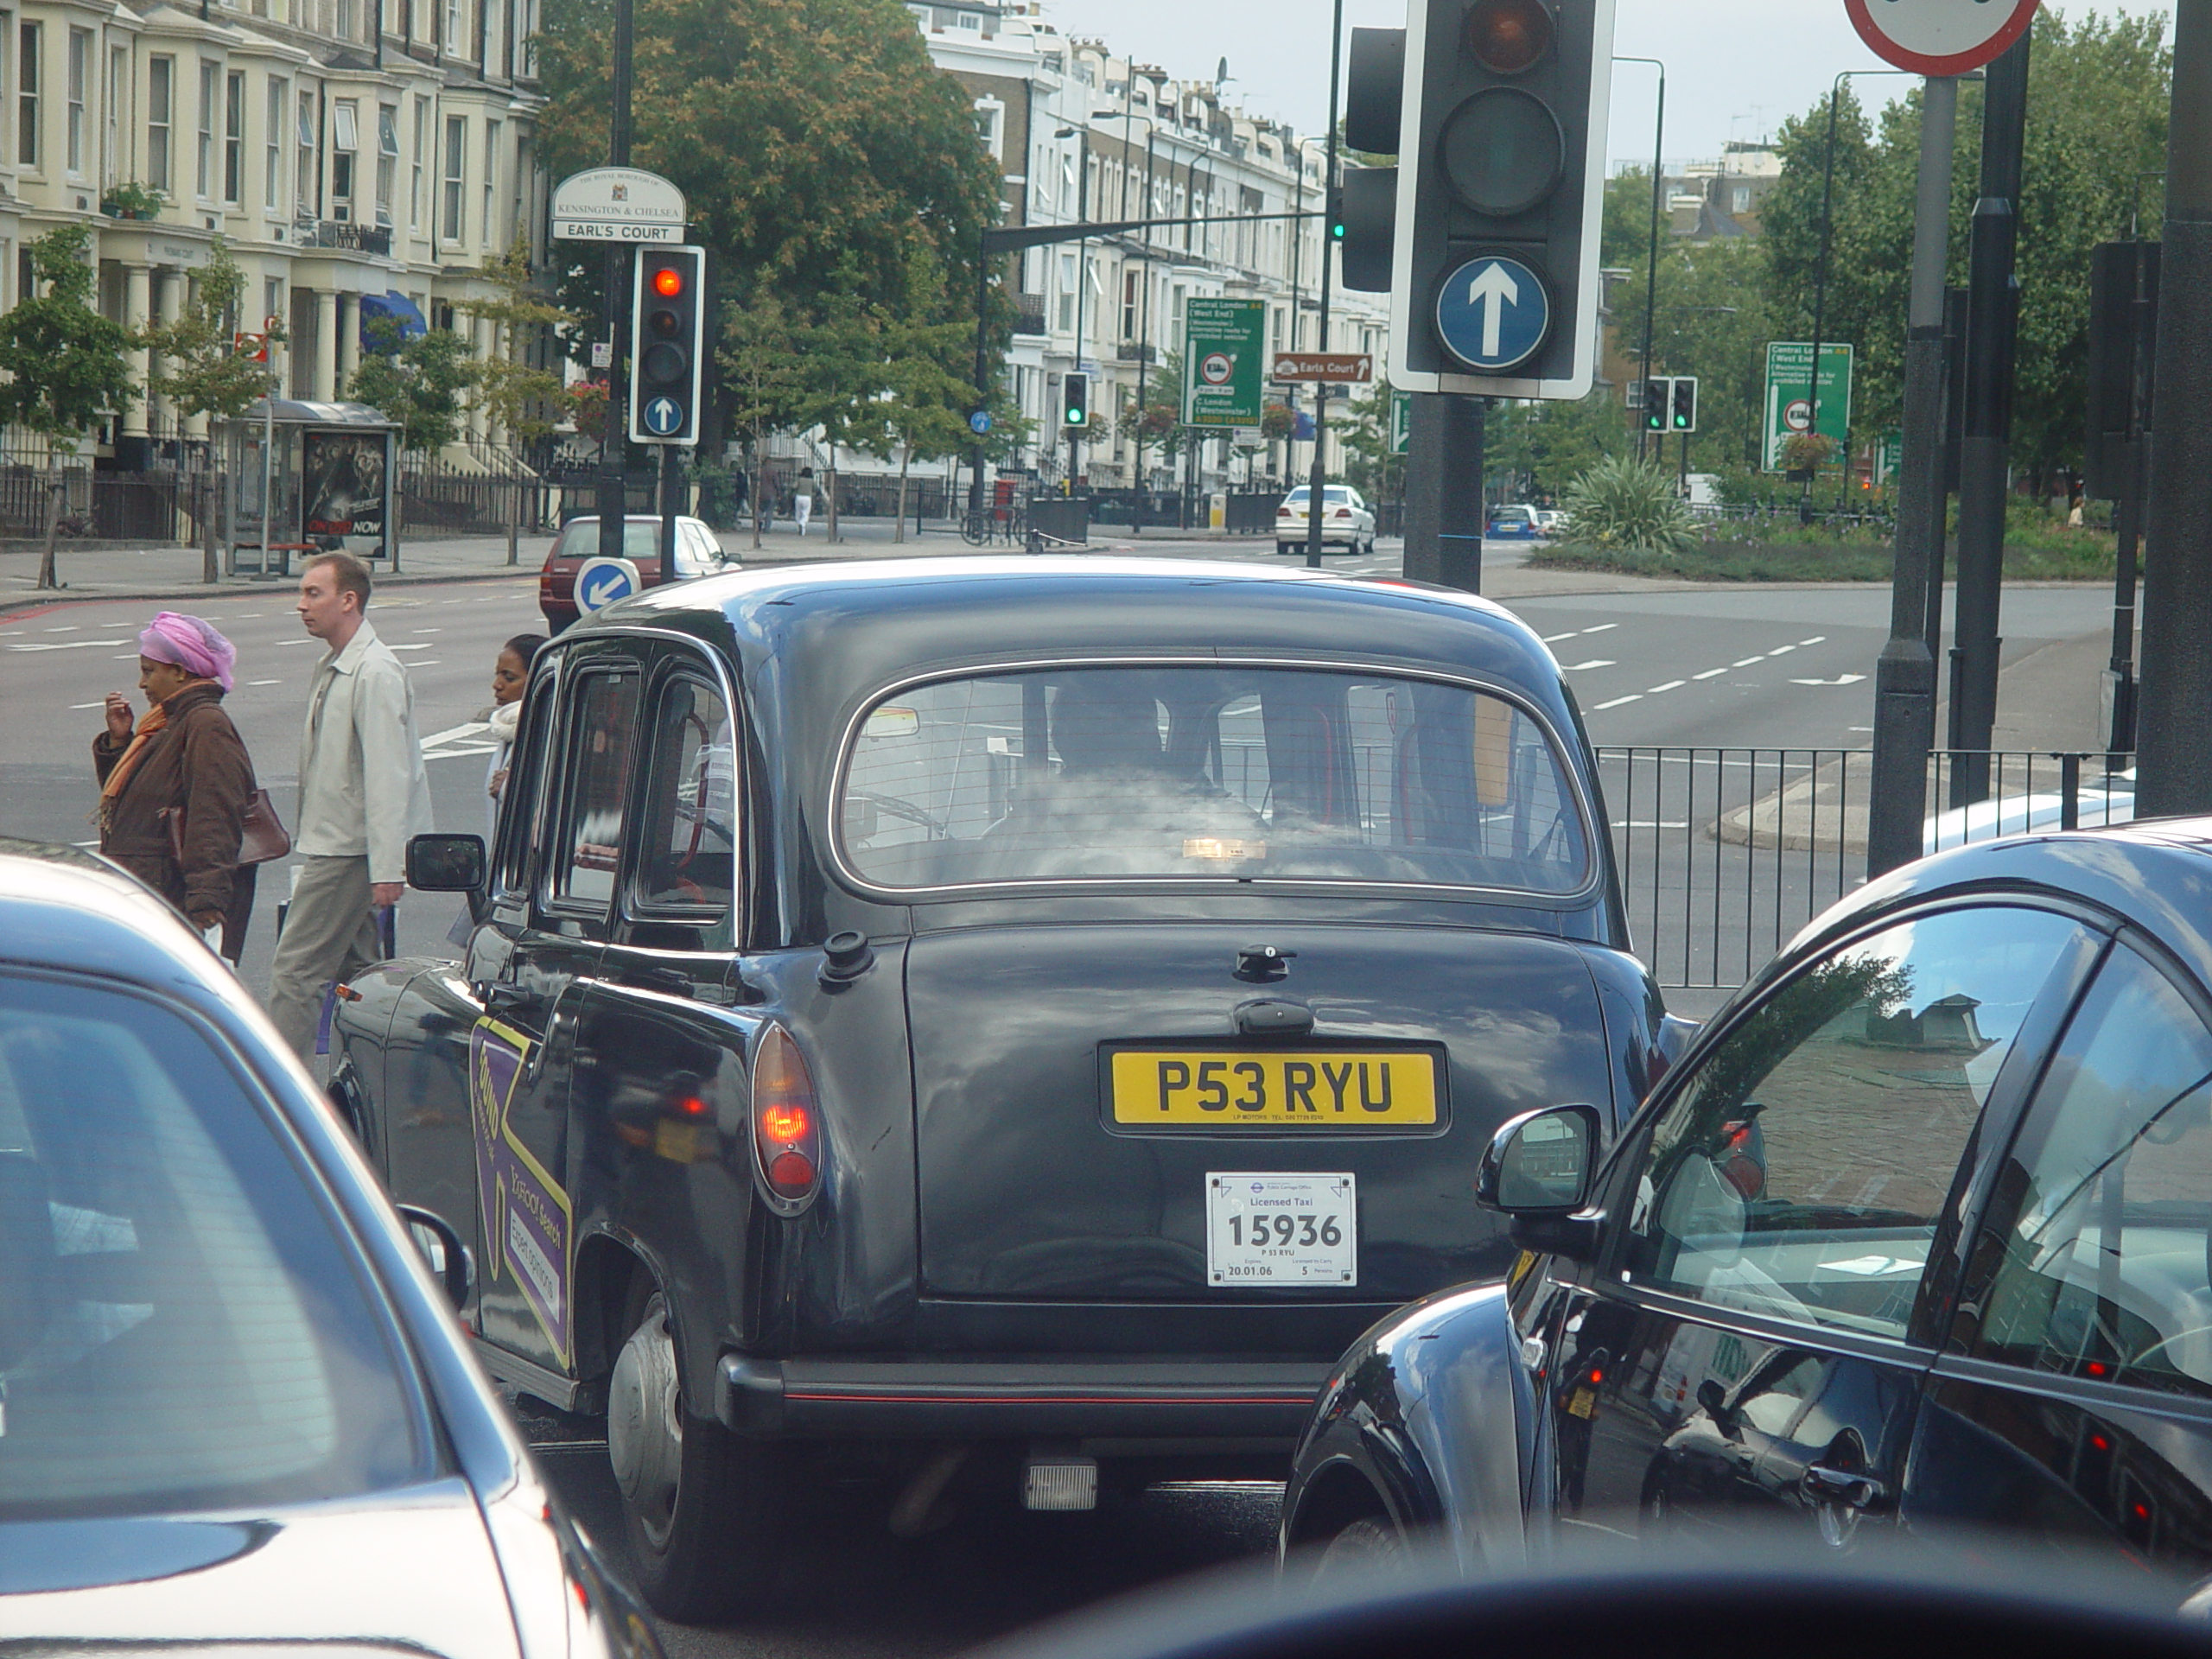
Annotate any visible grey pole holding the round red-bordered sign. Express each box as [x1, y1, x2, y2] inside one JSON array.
[[1867, 75, 1958, 880]]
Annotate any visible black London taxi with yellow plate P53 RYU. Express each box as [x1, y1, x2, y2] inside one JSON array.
[[332, 557, 1668, 1617]]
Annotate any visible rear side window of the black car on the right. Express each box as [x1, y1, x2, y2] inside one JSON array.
[[1975, 947, 2212, 1395]]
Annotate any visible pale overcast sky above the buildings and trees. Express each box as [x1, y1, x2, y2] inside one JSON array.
[[1044, 0, 2174, 162]]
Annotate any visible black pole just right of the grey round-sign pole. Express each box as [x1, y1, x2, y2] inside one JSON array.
[[1948, 33, 2031, 807]]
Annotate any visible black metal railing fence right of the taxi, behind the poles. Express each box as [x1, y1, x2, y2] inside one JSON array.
[[1597, 747, 2134, 988]]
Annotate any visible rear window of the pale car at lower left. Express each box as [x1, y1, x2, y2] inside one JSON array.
[[0, 978, 434, 1520]]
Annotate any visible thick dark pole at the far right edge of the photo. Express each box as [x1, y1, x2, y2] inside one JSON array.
[[2134, 0, 2212, 818]]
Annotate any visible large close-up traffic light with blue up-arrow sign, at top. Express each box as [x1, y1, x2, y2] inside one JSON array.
[[1380, 0, 1612, 398]]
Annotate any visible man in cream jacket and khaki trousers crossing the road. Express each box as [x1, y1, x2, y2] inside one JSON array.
[[268, 553, 431, 1059]]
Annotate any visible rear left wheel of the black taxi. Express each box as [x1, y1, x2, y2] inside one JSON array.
[[606, 1283, 781, 1624]]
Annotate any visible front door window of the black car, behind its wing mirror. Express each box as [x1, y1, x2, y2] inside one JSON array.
[[1621, 907, 2079, 1336]]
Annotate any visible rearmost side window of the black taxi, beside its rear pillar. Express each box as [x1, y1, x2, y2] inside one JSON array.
[[635, 675, 736, 918]]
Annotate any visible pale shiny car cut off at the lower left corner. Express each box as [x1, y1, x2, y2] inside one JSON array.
[[0, 841, 659, 1659]]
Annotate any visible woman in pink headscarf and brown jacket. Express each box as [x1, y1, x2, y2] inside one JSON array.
[[93, 611, 257, 963]]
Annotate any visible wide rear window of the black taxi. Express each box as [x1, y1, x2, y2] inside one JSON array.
[[841, 666, 1591, 893]]
